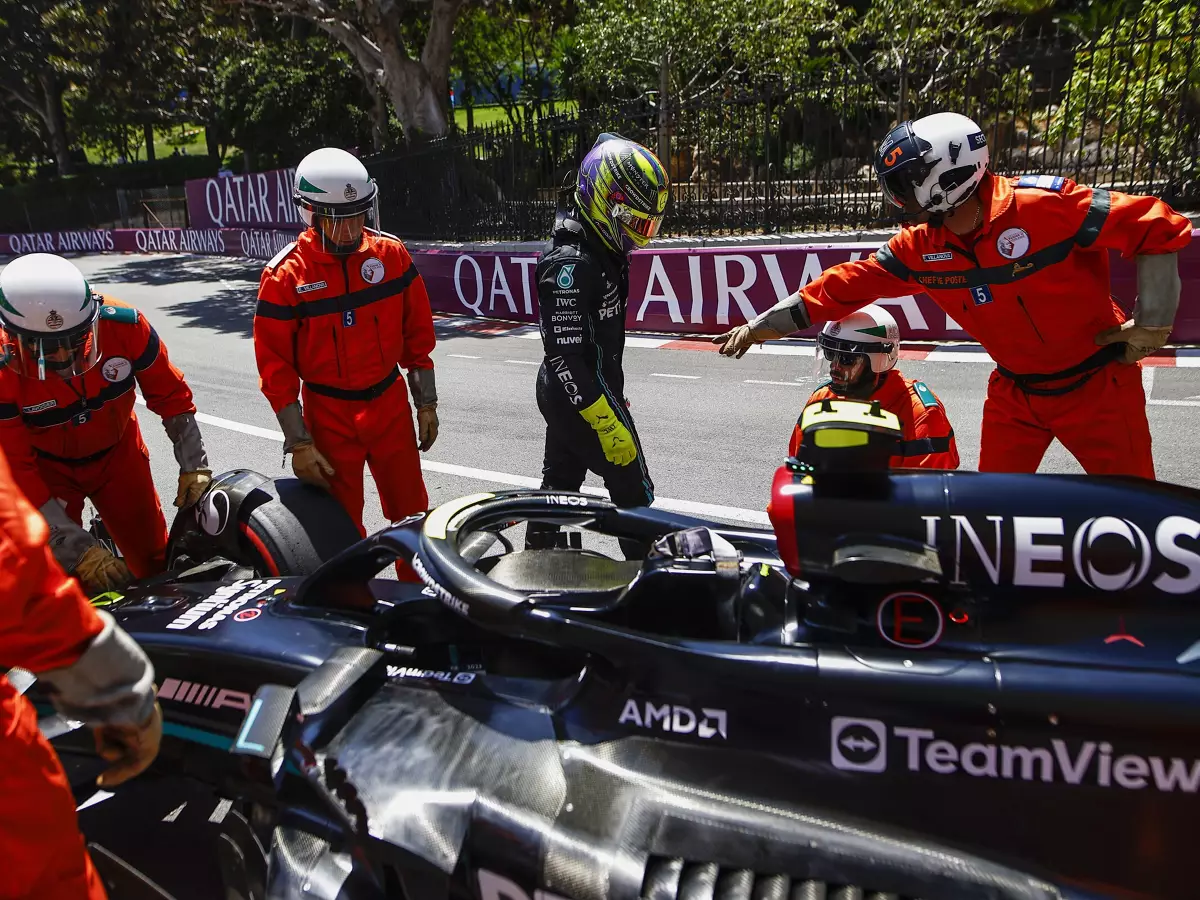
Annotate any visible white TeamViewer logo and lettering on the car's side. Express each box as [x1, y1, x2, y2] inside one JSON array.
[[829, 716, 1200, 793]]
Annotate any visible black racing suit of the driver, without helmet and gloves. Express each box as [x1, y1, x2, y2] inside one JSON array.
[[527, 210, 654, 557]]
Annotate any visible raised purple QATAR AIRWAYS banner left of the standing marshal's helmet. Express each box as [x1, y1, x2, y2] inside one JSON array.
[[184, 169, 304, 229]]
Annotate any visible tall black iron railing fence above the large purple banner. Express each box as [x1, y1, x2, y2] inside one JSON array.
[[367, 20, 1200, 240]]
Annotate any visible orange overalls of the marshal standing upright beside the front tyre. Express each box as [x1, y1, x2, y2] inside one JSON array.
[[254, 228, 434, 535]]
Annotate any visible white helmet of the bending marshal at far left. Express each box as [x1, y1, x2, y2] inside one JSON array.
[[0, 253, 100, 380]]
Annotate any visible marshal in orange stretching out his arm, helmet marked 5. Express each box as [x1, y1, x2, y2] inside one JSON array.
[[714, 113, 1192, 479]]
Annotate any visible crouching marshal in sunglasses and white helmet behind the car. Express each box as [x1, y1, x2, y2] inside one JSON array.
[[787, 304, 959, 469]]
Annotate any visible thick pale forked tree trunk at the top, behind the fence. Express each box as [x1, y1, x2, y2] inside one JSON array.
[[244, 0, 464, 137]]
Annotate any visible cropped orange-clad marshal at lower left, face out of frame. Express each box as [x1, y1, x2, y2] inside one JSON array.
[[0, 454, 162, 900]]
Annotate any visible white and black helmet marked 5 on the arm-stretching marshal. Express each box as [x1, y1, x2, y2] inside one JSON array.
[[875, 113, 990, 215]]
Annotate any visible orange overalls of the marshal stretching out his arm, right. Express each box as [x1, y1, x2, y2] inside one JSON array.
[[799, 175, 1192, 478]]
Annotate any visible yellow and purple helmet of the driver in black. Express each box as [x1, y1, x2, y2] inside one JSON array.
[[575, 132, 671, 253]]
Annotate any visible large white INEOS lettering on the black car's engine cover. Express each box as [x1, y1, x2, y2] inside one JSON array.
[[922, 516, 1200, 594]]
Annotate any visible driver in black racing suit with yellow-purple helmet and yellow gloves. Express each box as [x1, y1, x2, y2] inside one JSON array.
[[526, 133, 668, 559]]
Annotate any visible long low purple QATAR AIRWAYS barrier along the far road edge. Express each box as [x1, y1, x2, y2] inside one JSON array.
[[0, 228, 1200, 343]]
